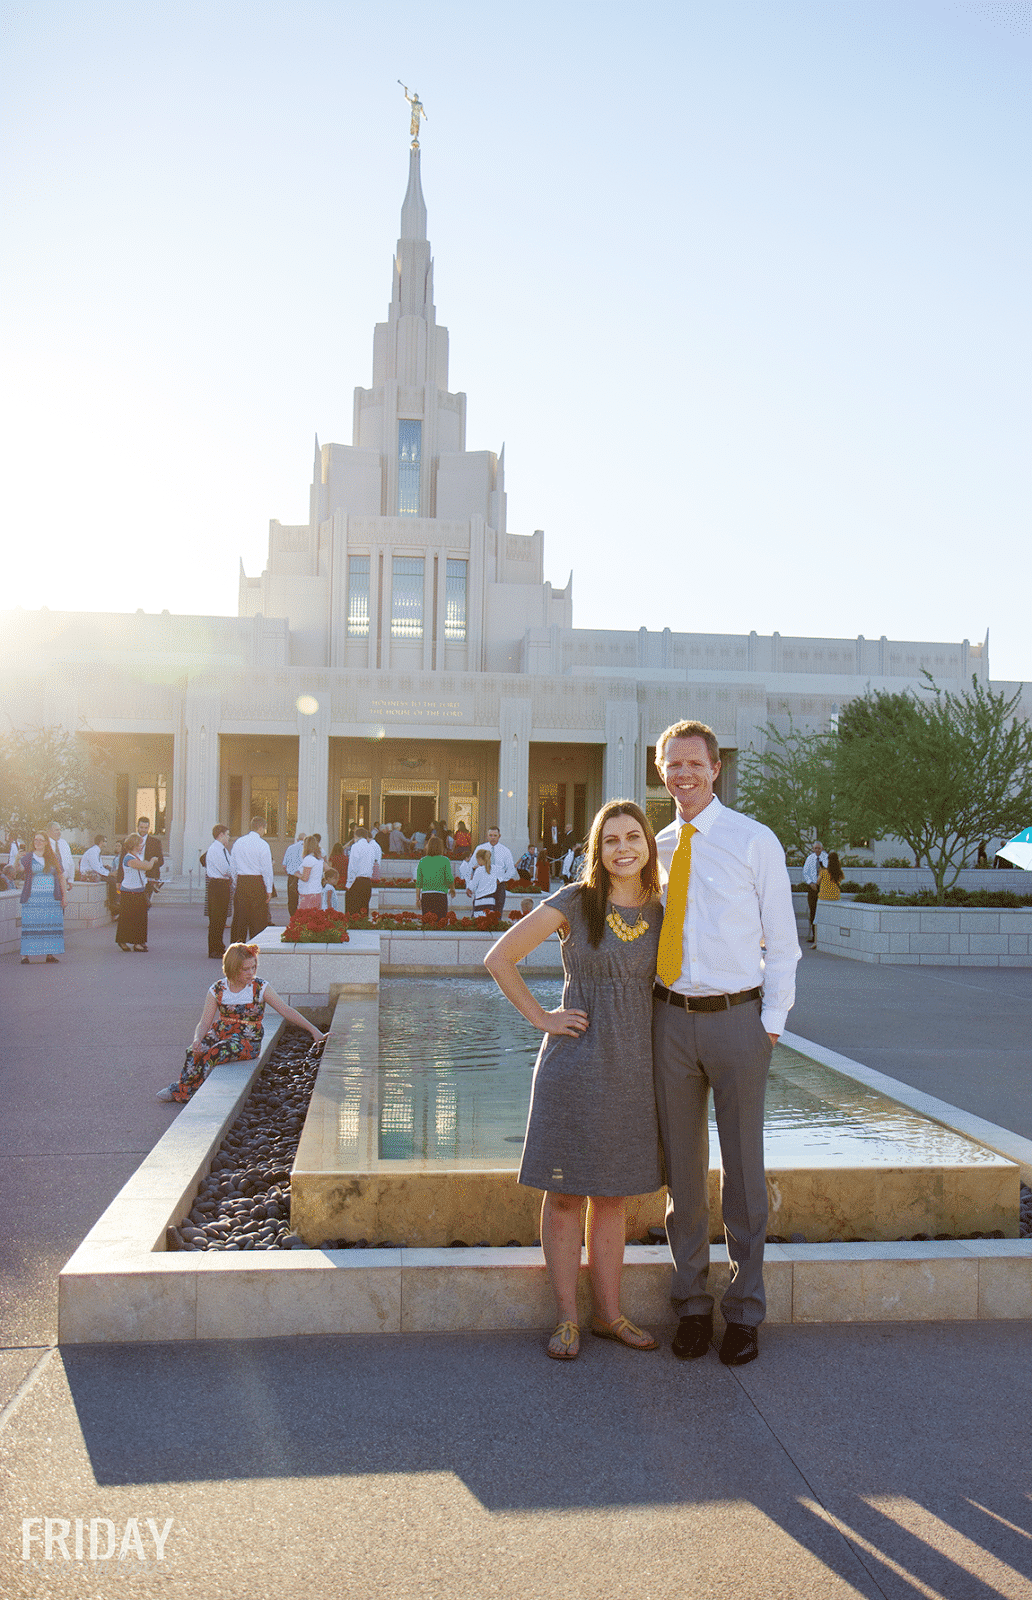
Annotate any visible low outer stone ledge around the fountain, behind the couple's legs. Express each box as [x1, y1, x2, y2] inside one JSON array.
[[58, 1029, 1032, 1344]]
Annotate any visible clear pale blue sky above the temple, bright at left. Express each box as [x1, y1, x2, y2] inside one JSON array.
[[0, 0, 1032, 680]]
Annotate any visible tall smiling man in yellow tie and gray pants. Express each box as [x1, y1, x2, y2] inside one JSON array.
[[653, 722, 802, 1366]]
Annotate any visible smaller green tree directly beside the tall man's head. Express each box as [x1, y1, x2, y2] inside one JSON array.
[[738, 718, 845, 854]]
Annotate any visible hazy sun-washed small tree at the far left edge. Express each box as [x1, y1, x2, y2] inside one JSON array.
[[0, 728, 104, 843]]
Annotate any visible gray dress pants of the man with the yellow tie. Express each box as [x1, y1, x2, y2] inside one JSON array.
[[653, 1000, 773, 1328]]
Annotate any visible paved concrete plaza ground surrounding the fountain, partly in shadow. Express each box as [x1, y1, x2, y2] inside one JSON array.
[[0, 901, 1032, 1600]]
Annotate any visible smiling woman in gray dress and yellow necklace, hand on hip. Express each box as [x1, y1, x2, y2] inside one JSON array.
[[483, 800, 662, 1362]]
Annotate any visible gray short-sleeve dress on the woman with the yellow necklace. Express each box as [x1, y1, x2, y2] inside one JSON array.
[[520, 883, 662, 1195]]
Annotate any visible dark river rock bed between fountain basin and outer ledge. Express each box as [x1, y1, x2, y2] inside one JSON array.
[[166, 1027, 1032, 1250]]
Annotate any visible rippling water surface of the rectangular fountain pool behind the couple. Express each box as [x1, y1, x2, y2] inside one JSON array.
[[379, 978, 997, 1168]]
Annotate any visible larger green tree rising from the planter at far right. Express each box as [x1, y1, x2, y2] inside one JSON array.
[[835, 672, 1032, 904]]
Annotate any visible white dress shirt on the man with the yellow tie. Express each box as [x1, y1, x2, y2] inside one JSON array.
[[656, 797, 802, 1034]]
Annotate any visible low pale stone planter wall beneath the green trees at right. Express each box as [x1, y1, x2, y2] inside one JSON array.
[[816, 902, 1032, 966]]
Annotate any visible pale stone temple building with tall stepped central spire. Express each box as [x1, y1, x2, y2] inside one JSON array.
[[3, 149, 989, 872]]
